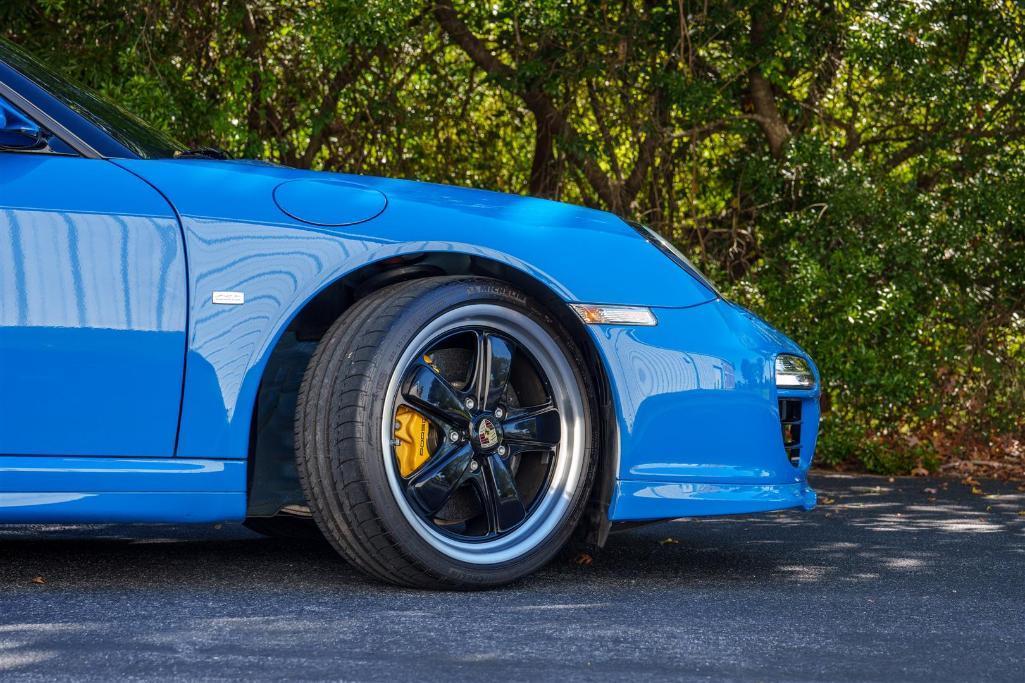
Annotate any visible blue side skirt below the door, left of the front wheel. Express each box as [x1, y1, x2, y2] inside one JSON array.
[[0, 455, 246, 524]]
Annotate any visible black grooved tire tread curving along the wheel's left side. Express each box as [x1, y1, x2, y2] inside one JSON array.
[[294, 277, 597, 590]]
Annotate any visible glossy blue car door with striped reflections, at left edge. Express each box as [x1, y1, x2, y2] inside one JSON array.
[[0, 107, 187, 456]]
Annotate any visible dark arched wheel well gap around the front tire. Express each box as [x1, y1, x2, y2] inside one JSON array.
[[247, 250, 618, 548]]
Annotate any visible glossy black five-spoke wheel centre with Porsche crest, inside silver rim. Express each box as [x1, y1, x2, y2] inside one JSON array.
[[396, 319, 564, 541]]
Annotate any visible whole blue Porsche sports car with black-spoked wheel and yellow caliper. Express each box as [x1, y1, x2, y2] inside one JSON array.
[[0, 42, 819, 589]]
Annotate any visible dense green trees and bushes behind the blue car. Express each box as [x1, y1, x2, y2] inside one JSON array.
[[0, 0, 1025, 472]]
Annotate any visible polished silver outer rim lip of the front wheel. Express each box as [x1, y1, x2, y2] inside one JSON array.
[[380, 304, 586, 565]]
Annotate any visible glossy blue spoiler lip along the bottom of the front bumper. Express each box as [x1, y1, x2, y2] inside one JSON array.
[[609, 480, 817, 522]]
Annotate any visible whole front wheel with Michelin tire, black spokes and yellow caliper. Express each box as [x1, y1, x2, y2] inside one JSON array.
[[296, 278, 597, 589]]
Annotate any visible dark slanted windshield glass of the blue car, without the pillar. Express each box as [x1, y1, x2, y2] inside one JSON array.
[[0, 39, 185, 159]]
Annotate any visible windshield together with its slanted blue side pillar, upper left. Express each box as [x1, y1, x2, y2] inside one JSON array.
[[0, 39, 186, 159]]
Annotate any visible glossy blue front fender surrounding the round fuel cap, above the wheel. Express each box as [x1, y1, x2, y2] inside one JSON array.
[[118, 160, 713, 458]]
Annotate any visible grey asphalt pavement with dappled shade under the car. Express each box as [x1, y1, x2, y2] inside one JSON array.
[[0, 475, 1025, 682]]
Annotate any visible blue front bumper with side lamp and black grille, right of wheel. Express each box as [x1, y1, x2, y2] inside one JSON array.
[[589, 299, 819, 521]]
